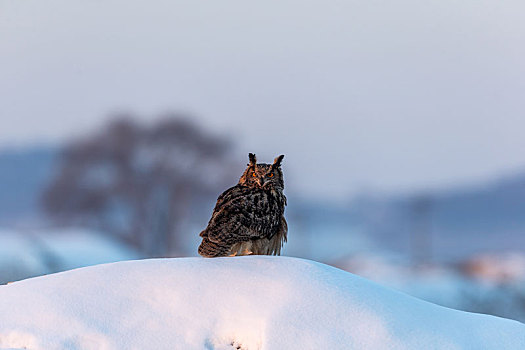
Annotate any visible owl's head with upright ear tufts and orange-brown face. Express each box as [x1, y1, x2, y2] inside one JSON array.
[[239, 153, 284, 190]]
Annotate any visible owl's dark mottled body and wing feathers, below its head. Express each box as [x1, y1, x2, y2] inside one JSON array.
[[200, 185, 287, 255]]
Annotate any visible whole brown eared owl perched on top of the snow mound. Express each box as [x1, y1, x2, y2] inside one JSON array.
[[199, 153, 288, 258]]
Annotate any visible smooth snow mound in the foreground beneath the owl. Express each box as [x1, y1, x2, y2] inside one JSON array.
[[0, 256, 525, 350]]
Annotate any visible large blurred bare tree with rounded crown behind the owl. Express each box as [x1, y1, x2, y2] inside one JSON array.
[[42, 114, 232, 256]]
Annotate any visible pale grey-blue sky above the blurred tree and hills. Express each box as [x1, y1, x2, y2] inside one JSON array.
[[0, 0, 525, 198]]
